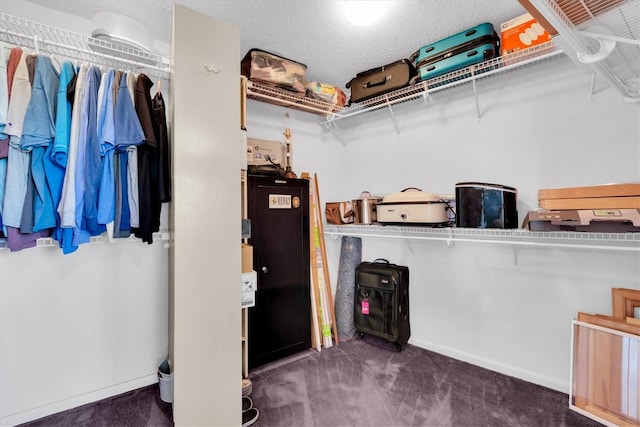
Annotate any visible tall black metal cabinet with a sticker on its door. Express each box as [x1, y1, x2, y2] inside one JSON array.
[[247, 175, 311, 369]]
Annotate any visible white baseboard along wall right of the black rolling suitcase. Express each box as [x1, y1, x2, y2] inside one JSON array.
[[409, 338, 569, 394]]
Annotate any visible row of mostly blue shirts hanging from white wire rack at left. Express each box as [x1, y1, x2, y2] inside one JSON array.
[[0, 15, 168, 254]]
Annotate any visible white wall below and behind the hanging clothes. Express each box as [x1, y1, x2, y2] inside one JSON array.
[[0, 1, 169, 426]]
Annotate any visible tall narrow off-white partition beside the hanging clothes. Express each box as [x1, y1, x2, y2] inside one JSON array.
[[170, 5, 242, 426]]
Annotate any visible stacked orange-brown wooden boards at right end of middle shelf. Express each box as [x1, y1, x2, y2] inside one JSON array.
[[538, 183, 640, 210]]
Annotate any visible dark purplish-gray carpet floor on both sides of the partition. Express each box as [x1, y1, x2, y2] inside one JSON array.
[[17, 336, 600, 427]]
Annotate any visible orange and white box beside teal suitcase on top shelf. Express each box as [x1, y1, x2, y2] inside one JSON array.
[[500, 12, 551, 55]]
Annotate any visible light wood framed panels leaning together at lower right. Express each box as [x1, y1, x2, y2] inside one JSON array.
[[573, 288, 640, 427]]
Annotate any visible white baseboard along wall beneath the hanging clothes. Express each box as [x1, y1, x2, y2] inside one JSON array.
[[0, 373, 158, 427]]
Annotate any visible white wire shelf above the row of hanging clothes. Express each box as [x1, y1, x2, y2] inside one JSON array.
[[0, 13, 170, 79]]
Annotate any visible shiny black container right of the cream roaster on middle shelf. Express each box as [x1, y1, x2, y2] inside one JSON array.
[[456, 182, 518, 228]]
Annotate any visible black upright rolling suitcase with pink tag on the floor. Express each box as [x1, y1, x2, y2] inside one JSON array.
[[353, 259, 411, 351]]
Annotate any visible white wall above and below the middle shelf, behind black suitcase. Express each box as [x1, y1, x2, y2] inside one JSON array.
[[248, 57, 640, 392]]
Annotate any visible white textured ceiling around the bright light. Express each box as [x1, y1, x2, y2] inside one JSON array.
[[25, 0, 525, 88]]
